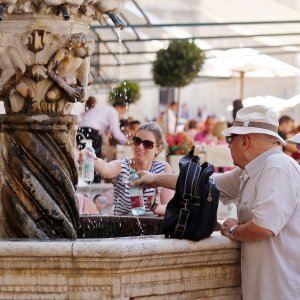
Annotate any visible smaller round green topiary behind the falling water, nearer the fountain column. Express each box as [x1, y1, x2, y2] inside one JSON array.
[[108, 80, 141, 105]]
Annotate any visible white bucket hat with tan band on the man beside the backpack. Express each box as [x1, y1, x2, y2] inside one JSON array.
[[221, 105, 286, 145]]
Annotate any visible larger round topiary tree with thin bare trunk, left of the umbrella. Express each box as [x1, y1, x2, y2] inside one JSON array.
[[152, 40, 205, 132]]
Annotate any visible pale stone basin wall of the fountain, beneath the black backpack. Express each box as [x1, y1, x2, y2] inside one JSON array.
[[0, 232, 241, 300]]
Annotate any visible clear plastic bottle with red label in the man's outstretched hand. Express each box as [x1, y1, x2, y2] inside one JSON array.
[[128, 169, 145, 216]]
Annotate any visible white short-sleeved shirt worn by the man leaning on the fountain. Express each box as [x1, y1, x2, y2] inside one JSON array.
[[214, 149, 300, 300]]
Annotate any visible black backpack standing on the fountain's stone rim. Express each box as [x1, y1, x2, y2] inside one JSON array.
[[162, 146, 220, 241]]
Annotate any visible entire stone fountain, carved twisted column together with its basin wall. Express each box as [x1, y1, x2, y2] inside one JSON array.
[[0, 0, 241, 300]]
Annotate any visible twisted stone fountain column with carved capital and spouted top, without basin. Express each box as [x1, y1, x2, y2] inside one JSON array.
[[0, 0, 124, 239]]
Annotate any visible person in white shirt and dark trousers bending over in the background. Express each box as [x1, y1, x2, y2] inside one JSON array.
[[76, 97, 127, 157]]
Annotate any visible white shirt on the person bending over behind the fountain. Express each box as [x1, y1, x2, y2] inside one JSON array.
[[79, 105, 127, 144]]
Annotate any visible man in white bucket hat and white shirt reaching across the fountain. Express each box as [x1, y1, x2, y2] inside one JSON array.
[[130, 105, 300, 300]]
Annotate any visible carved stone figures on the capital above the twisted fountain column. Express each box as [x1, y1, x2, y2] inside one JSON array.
[[0, 30, 94, 114]]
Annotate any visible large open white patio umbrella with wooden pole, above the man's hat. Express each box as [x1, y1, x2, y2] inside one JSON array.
[[200, 48, 300, 100]]
